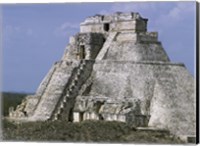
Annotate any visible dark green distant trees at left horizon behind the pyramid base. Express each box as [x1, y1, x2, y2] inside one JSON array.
[[1, 92, 28, 116]]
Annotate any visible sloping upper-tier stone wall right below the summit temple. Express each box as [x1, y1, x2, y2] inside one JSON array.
[[100, 32, 169, 62]]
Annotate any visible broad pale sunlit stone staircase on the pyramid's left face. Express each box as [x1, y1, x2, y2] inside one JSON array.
[[30, 61, 80, 121]]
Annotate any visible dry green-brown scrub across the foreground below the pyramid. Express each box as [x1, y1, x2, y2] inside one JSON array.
[[3, 119, 182, 144]]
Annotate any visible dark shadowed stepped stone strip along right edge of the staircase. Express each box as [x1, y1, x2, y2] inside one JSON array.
[[51, 60, 94, 120]]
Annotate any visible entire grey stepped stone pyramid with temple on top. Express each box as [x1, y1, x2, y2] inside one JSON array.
[[8, 12, 196, 140]]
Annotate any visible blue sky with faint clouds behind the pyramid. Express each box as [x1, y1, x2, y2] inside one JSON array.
[[2, 2, 196, 92]]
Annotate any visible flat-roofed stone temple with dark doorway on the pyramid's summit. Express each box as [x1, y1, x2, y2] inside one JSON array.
[[80, 13, 147, 33]]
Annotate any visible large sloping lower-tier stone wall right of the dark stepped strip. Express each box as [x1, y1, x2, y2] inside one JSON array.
[[84, 61, 195, 135]]
